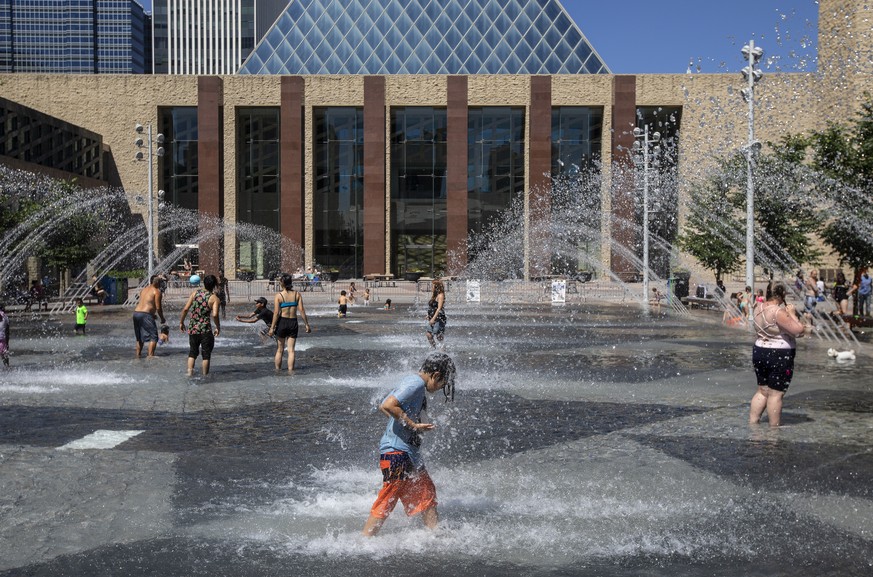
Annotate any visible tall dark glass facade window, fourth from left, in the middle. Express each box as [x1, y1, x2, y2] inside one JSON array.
[[391, 107, 447, 277]]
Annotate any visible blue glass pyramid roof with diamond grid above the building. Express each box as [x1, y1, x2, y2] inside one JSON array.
[[239, 0, 609, 74]]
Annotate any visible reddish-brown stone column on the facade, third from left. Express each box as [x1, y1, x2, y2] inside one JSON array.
[[362, 76, 388, 274]]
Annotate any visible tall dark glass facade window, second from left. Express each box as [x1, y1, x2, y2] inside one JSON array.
[[236, 108, 281, 278]]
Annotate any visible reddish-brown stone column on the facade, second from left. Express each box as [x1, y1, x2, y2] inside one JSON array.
[[279, 76, 305, 273]]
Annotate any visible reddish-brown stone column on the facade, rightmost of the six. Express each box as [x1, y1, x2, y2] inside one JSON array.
[[609, 76, 637, 280]]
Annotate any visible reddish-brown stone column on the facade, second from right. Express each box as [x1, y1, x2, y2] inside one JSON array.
[[527, 76, 552, 277]]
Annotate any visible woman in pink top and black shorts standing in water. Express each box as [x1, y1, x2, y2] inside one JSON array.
[[749, 284, 806, 427]]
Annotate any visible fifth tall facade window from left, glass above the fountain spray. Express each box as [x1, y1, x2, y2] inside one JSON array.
[[467, 107, 525, 250]]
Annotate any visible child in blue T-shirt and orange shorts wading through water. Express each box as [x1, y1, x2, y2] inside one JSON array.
[[362, 352, 455, 537]]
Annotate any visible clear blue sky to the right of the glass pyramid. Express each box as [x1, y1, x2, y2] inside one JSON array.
[[136, 0, 818, 74]]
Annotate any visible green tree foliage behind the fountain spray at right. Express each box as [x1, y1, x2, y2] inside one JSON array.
[[679, 94, 873, 278]]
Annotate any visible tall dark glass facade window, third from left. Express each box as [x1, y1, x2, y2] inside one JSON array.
[[313, 107, 365, 278]]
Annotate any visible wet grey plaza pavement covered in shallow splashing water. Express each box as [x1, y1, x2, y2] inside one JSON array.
[[0, 304, 873, 576]]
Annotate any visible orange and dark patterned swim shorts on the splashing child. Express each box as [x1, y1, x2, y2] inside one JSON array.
[[370, 451, 437, 519]]
